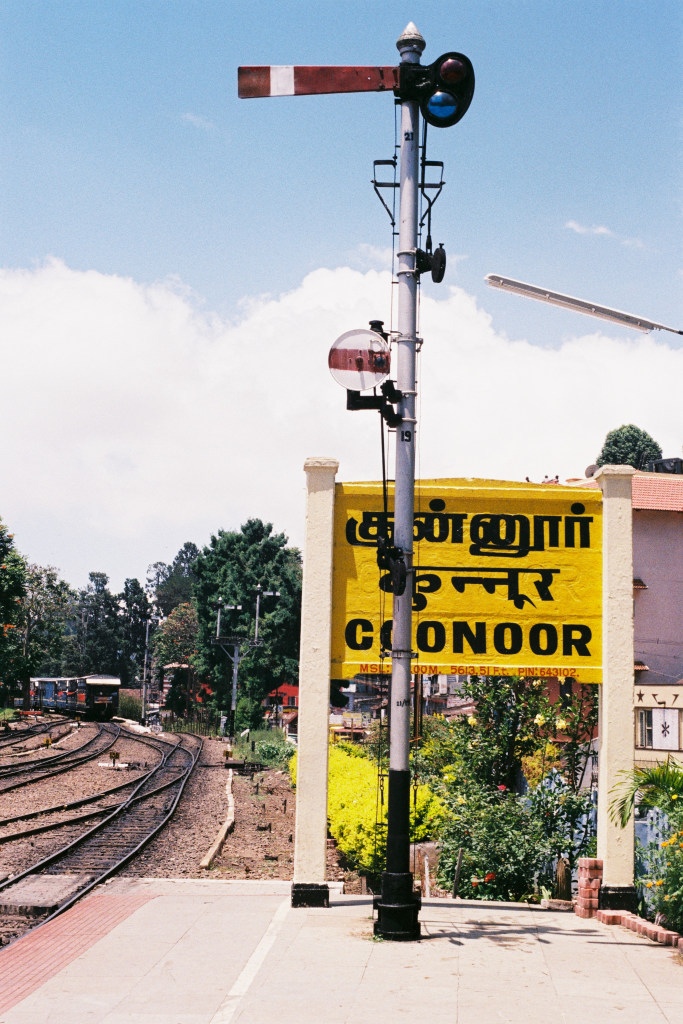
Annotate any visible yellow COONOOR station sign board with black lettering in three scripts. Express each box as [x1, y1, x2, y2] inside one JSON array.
[[332, 479, 602, 683]]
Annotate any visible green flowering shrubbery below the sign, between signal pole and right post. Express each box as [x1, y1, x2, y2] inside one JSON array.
[[413, 676, 597, 899]]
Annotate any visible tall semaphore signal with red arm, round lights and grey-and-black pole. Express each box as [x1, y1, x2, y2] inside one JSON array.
[[238, 23, 474, 940]]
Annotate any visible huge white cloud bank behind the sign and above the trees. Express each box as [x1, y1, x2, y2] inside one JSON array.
[[0, 260, 683, 587]]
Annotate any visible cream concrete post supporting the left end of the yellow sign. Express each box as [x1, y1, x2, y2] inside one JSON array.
[[292, 458, 339, 906]]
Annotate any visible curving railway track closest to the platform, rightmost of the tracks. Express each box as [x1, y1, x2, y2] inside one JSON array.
[[0, 735, 203, 924]]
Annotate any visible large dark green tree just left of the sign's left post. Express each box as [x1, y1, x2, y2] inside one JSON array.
[[194, 519, 301, 728]]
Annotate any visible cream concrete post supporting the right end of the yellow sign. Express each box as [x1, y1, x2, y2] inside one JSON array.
[[595, 466, 637, 910]]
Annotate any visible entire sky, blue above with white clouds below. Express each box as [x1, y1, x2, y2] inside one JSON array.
[[0, 0, 683, 586]]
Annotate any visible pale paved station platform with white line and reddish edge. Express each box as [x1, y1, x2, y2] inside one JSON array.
[[0, 879, 683, 1024]]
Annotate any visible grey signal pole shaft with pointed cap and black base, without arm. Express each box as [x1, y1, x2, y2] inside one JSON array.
[[375, 25, 425, 940]]
